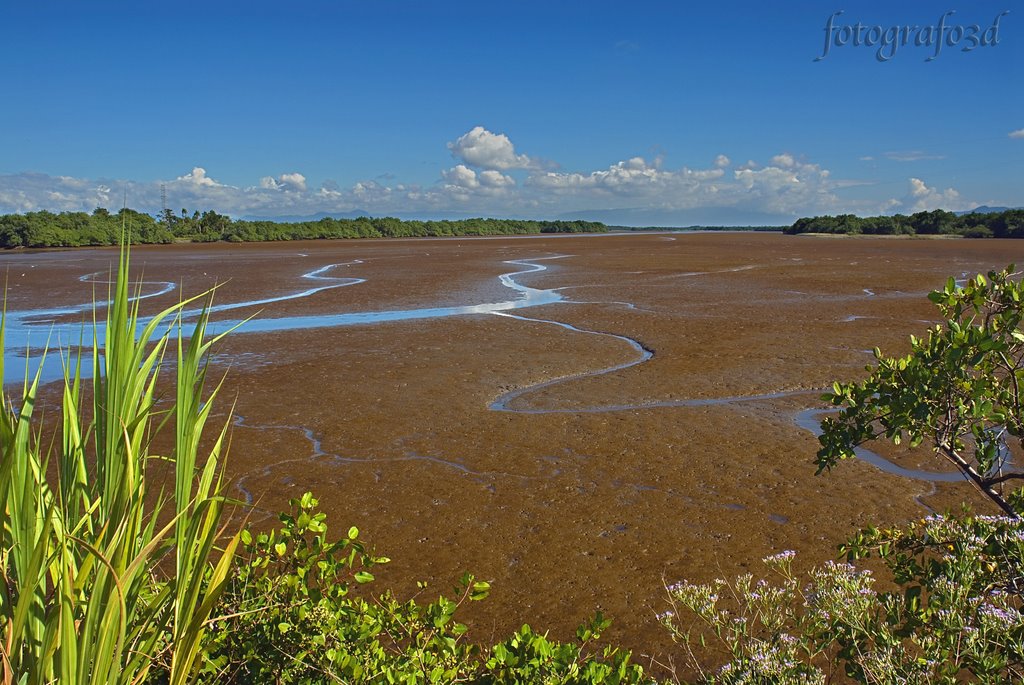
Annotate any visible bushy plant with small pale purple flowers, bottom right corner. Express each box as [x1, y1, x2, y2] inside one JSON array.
[[658, 516, 1024, 683]]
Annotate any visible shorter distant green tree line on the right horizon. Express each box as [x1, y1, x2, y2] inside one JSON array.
[[784, 209, 1024, 238]]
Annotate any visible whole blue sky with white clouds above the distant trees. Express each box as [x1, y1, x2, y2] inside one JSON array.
[[0, 0, 1024, 225]]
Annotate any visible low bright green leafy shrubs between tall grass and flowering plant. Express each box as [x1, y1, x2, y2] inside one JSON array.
[[204, 493, 643, 684]]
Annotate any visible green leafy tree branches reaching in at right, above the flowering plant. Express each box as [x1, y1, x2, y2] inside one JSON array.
[[817, 265, 1024, 518]]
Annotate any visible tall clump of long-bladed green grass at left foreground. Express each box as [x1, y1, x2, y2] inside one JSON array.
[[0, 242, 238, 685]]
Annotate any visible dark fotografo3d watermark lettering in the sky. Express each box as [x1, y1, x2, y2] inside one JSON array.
[[814, 9, 1010, 61]]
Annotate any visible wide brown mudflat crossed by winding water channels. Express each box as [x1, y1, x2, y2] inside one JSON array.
[[0, 233, 1024, 653]]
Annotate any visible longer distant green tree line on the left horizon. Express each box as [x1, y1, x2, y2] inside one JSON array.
[[0, 208, 608, 248]]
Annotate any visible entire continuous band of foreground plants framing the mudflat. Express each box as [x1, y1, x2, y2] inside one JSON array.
[[0, 239, 1024, 685]]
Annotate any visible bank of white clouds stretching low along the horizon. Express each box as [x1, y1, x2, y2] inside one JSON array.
[[0, 126, 983, 224]]
